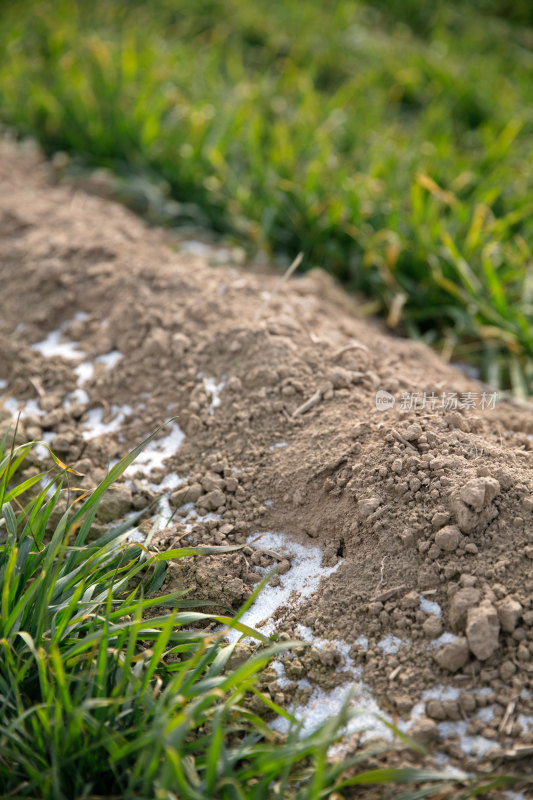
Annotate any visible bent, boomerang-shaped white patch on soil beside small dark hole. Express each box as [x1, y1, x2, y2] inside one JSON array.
[[224, 533, 341, 641]]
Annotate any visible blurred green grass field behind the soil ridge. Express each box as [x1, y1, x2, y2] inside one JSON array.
[[0, 0, 533, 396]]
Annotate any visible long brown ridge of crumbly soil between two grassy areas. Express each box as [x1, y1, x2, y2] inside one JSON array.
[[0, 142, 533, 780]]
